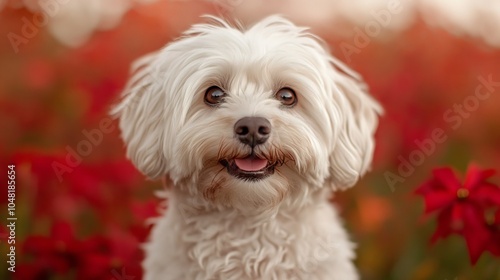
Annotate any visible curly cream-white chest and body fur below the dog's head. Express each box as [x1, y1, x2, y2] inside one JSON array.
[[144, 194, 356, 280]]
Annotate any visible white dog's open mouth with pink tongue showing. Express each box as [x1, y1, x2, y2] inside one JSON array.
[[220, 155, 275, 181]]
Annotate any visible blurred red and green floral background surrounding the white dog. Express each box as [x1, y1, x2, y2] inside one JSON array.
[[0, 0, 500, 280]]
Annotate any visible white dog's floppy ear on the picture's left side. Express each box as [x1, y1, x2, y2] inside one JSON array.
[[111, 54, 166, 178]]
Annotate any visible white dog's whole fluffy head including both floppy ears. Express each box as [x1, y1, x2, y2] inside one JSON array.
[[115, 17, 381, 209]]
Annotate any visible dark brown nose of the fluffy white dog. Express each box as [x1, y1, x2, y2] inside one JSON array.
[[234, 117, 271, 148]]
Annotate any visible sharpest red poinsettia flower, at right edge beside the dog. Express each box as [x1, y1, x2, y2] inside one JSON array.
[[415, 165, 500, 264]]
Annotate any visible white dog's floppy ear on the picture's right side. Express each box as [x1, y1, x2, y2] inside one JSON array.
[[327, 57, 383, 190]]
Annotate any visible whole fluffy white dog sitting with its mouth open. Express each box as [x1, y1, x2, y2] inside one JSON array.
[[114, 16, 381, 280]]
